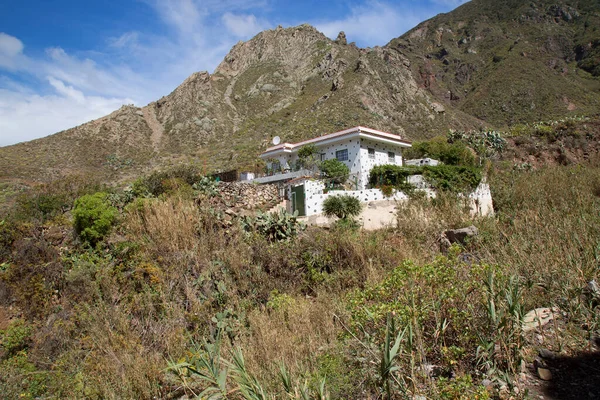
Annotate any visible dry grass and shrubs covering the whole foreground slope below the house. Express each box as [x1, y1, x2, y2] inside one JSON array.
[[0, 119, 600, 399]]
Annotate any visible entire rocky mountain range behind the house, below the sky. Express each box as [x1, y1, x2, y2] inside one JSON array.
[[0, 0, 600, 180]]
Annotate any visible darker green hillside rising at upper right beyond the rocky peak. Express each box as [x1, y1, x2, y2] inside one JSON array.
[[394, 0, 600, 127]]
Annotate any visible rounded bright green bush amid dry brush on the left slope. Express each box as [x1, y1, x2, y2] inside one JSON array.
[[73, 192, 117, 245]]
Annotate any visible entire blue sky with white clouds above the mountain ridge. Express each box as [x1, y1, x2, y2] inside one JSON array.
[[0, 0, 466, 146]]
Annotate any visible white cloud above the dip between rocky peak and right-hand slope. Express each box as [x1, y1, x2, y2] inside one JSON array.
[[315, 1, 423, 45]]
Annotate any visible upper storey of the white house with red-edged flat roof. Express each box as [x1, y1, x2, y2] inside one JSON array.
[[254, 126, 411, 190]]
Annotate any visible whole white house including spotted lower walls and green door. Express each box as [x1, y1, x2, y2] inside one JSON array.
[[253, 126, 411, 216]]
